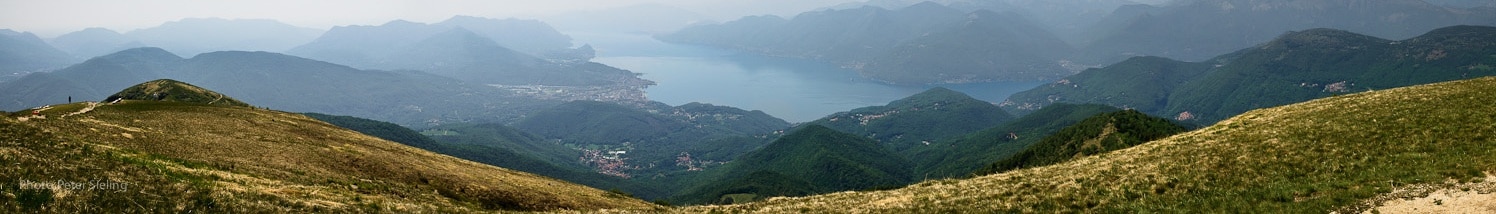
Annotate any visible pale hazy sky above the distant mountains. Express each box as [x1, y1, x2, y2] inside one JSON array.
[[0, 0, 853, 37]]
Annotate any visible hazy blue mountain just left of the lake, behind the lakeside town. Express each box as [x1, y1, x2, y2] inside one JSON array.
[[287, 16, 651, 88]]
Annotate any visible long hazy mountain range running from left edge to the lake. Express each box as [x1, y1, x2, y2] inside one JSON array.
[[24, 16, 652, 88]]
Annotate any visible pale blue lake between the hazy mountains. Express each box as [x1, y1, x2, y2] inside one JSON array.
[[568, 33, 1046, 123]]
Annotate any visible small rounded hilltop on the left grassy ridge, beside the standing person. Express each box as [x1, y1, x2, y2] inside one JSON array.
[[105, 79, 250, 106]]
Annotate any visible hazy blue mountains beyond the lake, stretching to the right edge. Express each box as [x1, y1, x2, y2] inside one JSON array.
[[670, 0, 1496, 84]]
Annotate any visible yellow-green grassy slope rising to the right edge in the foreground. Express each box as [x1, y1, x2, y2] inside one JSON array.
[[681, 78, 1496, 213]]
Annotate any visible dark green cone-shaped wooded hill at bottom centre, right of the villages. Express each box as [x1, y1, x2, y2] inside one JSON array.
[[676, 124, 913, 204]]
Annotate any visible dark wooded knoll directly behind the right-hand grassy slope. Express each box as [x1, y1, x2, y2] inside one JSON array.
[[975, 109, 1189, 175]]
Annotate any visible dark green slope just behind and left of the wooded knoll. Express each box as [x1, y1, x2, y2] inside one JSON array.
[[901, 105, 1121, 180]]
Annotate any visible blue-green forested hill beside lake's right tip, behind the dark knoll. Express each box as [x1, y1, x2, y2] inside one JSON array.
[[998, 57, 1210, 115]]
